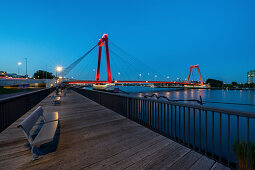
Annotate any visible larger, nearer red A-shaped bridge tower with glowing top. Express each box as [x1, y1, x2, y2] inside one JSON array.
[[96, 34, 112, 83]]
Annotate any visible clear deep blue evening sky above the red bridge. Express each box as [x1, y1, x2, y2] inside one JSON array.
[[0, 0, 255, 82]]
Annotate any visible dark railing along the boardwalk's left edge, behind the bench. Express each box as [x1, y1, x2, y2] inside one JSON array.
[[0, 88, 54, 133]]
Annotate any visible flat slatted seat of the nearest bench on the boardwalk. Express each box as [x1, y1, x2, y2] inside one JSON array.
[[31, 121, 58, 146]]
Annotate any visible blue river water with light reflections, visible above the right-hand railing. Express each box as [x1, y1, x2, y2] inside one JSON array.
[[119, 86, 255, 113]]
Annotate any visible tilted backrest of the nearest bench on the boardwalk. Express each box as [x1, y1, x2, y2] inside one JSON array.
[[18, 106, 43, 142]]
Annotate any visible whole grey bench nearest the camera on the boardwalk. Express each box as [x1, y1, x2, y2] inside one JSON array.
[[18, 106, 58, 160]]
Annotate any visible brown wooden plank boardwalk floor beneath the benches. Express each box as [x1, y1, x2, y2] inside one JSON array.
[[0, 89, 228, 170]]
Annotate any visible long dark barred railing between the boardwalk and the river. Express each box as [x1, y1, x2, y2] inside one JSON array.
[[74, 88, 255, 169]]
